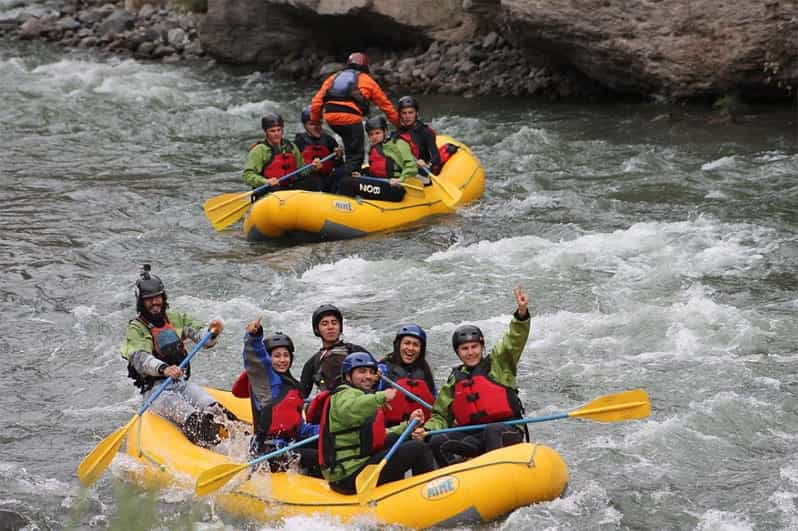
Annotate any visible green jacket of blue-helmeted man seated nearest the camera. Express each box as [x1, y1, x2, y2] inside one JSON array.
[[322, 385, 407, 482]]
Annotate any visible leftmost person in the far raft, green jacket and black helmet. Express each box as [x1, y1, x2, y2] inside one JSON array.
[[243, 113, 322, 201]]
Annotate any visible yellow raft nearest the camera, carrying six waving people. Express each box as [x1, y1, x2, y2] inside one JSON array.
[[120, 389, 568, 528]]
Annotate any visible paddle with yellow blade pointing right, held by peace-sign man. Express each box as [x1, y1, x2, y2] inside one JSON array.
[[427, 389, 651, 435]]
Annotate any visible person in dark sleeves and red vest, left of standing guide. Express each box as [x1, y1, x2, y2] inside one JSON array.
[[294, 107, 343, 192]]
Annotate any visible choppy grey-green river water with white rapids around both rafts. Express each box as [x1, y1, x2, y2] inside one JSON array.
[[0, 36, 798, 530]]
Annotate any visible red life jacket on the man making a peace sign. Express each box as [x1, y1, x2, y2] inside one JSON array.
[[450, 356, 524, 426]]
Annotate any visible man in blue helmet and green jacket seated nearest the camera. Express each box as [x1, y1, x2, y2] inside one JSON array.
[[319, 352, 435, 494]]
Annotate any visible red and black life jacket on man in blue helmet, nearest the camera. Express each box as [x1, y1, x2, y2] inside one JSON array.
[[318, 386, 386, 469]]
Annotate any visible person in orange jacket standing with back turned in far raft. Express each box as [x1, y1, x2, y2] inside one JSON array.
[[310, 52, 399, 185]]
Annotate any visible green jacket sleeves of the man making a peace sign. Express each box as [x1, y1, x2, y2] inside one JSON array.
[[424, 314, 532, 431]]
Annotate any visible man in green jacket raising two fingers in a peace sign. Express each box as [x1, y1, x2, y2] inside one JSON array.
[[413, 286, 530, 466]]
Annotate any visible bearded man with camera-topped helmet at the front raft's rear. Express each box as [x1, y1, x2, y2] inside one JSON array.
[[120, 264, 235, 447]]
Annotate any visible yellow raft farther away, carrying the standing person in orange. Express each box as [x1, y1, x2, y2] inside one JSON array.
[[244, 135, 485, 241]]
